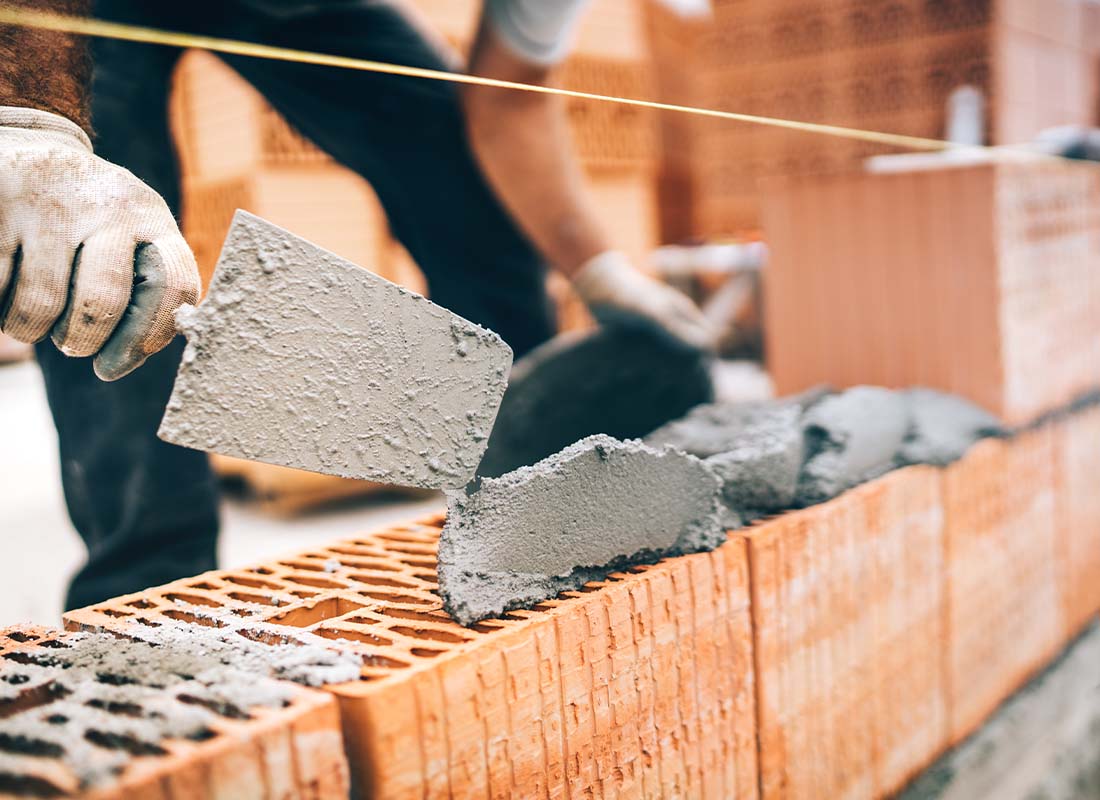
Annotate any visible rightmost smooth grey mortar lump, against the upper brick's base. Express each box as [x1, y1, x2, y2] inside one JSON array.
[[898, 388, 1007, 467]]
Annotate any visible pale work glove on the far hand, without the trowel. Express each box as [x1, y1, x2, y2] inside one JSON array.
[[573, 251, 716, 350]]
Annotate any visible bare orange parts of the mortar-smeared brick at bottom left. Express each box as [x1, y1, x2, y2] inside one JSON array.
[[0, 625, 349, 800]]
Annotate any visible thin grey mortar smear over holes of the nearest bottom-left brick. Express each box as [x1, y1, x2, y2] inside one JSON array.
[[0, 625, 359, 788]]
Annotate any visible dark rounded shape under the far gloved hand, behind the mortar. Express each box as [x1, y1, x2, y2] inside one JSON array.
[[477, 326, 714, 478]]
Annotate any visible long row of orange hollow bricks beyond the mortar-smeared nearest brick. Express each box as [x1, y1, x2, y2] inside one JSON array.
[[42, 407, 1100, 798]]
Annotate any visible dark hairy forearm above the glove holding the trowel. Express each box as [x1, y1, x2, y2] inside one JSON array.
[[0, 0, 90, 130]]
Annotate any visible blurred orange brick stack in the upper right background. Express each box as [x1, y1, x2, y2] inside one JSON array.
[[651, 0, 1100, 238]]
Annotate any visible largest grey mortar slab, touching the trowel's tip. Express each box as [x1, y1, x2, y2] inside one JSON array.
[[439, 436, 725, 625]]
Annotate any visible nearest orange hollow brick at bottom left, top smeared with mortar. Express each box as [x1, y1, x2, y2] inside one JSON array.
[[0, 626, 348, 800]]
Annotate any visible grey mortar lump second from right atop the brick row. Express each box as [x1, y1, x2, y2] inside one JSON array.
[[795, 386, 909, 506]]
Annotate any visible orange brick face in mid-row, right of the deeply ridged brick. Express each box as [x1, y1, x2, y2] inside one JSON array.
[[745, 467, 947, 799]]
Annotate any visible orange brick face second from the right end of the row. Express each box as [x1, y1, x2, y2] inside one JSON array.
[[943, 426, 1064, 743]]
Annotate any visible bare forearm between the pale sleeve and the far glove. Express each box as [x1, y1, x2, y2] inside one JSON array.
[[463, 31, 611, 276]]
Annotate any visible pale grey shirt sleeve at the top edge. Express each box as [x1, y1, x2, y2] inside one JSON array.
[[484, 0, 590, 66]]
